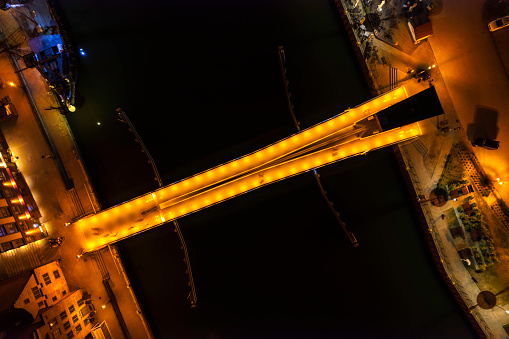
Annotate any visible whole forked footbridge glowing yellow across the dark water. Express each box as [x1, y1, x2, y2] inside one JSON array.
[[72, 88, 438, 253]]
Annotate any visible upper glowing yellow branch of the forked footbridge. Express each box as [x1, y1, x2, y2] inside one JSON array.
[[77, 87, 408, 235]]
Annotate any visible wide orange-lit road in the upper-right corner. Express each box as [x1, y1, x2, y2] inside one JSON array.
[[429, 0, 509, 201]]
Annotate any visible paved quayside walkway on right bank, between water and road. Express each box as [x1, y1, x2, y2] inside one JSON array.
[[336, 0, 509, 338]]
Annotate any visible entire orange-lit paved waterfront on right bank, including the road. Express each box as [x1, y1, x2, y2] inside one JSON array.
[[336, 0, 509, 338]]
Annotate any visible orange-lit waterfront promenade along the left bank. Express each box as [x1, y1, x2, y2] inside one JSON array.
[[0, 1, 149, 338]]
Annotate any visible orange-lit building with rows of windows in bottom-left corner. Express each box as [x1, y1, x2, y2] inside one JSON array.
[[0, 261, 111, 339]]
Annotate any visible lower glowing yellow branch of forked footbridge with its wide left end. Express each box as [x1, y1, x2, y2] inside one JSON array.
[[76, 123, 422, 251]]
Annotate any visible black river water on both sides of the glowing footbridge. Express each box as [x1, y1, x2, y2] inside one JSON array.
[[55, 0, 475, 338]]
